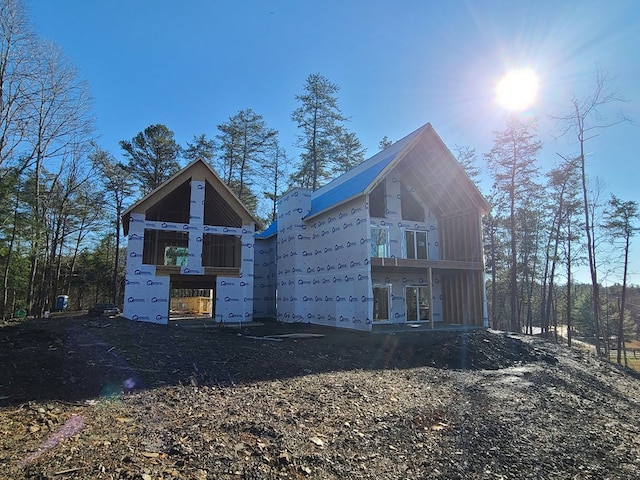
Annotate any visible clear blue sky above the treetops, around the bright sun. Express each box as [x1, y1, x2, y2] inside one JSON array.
[[27, 0, 640, 283]]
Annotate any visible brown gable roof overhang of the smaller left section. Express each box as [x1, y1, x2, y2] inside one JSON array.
[[122, 159, 260, 235]]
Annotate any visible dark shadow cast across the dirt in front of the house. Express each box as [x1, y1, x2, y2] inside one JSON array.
[[0, 317, 555, 406]]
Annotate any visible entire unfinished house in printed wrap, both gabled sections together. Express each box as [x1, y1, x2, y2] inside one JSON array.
[[124, 124, 489, 330]]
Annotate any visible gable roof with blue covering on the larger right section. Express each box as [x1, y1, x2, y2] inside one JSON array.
[[305, 123, 490, 219]]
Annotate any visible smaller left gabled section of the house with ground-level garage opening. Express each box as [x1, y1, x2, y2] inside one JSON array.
[[123, 160, 257, 323]]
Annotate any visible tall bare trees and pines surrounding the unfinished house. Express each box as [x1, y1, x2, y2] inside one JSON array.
[[0, 0, 640, 362]]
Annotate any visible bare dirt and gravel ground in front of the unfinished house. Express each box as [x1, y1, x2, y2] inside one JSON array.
[[0, 317, 640, 480]]
